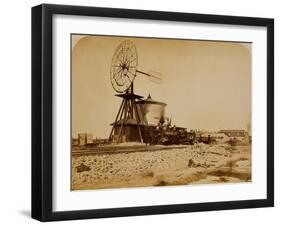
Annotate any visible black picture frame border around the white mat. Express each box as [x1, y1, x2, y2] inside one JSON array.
[[32, 4, 274, 221]]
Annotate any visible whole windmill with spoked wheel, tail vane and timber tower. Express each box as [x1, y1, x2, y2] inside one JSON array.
[[108, 40, 161, 143]]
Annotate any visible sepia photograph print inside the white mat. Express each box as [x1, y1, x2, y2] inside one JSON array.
[[71, 34, 252, 190]]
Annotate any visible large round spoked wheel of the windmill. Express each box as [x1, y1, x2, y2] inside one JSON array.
[[110, 40, 138, 93]]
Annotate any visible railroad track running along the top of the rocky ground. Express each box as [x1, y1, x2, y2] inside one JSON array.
[[72, 145, 190, 156]]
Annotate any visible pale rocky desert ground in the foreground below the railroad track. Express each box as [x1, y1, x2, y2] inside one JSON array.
[[72, 143, 251, 190]]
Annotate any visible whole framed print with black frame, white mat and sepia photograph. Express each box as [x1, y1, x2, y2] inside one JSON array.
[[32, 4, 274, 221]]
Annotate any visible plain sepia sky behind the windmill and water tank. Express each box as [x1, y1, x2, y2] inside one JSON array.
[[72, 35, 251, 138]]
